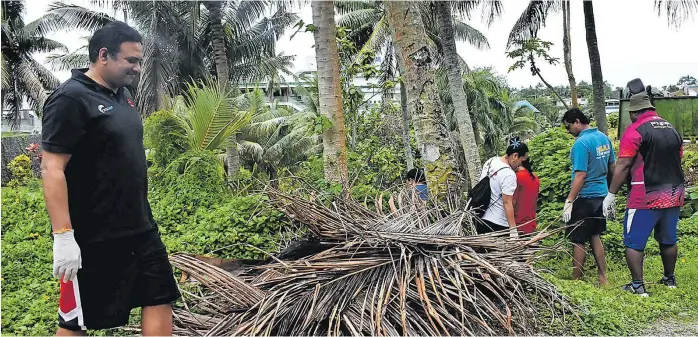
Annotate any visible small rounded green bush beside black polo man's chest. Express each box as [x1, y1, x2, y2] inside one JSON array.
[[143, 110, 187, 167]]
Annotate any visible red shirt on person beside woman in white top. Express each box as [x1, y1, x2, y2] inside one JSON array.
[[514, 169, 540, 234]]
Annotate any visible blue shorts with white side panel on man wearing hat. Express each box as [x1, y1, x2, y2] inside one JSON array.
[[623, 207, 681, 250]]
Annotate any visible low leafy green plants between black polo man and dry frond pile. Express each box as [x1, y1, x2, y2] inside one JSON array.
[[166, 194, 288, 259]]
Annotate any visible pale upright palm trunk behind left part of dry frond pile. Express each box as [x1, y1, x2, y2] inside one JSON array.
[[311, 1, 349, 189]]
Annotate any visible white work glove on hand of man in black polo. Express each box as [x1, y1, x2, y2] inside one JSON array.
[[53, 231, 82, 283]]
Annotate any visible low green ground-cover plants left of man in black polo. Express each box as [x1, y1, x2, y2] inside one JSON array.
[[2, 187, 58, 335]]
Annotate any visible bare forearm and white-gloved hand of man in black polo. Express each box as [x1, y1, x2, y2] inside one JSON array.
[[41, 151, 82, 282]]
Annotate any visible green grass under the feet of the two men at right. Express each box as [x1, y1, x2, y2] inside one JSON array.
[[541, 232, 698, 335]]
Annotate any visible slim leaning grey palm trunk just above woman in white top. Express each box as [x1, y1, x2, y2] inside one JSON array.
[[435, 1, 482, 185]]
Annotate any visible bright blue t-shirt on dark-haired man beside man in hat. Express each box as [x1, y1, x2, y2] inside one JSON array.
[[570, 128, 616, 198]]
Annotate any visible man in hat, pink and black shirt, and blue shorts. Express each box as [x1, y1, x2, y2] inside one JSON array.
[[604, 84, 685, 297]]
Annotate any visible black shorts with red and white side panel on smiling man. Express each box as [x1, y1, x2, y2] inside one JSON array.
[[58, 230, 180, 331]]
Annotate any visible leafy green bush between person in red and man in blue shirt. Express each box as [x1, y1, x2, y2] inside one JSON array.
[[528, 128, 574, 205]]
